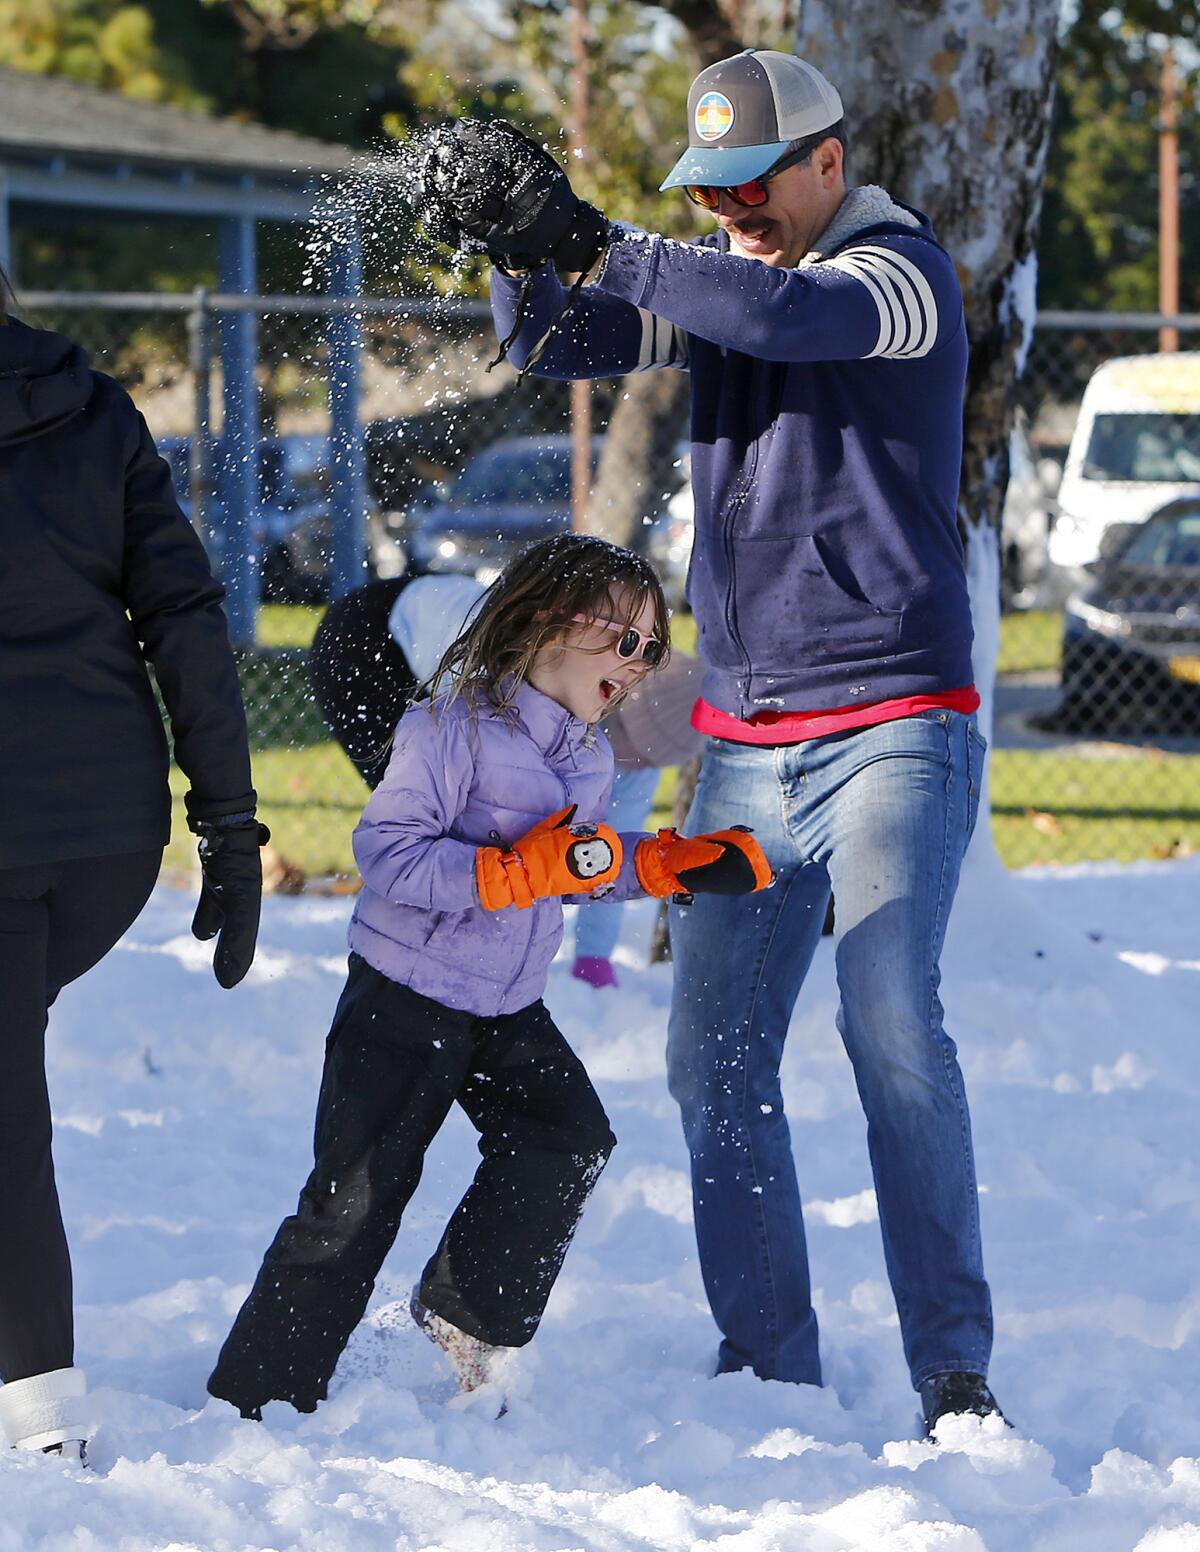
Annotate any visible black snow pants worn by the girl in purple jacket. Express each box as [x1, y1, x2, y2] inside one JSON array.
[[208, 954, 613, 1412]]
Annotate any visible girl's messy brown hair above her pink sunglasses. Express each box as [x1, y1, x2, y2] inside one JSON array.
[[428, 534, 671, 711]]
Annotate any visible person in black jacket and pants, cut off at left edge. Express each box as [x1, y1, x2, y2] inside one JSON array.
[[0, 272, 265, 1457]]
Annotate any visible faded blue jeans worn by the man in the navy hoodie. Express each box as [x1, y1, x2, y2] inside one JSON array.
[[668, 711, 992, 1386]]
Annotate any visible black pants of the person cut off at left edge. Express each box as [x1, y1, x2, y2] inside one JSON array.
[[0, 850, 163, 1381]]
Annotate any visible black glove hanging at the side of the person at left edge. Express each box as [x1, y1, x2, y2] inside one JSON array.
[[188, 813, 270, 990]]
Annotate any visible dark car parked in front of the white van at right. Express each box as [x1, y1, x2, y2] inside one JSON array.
[[1054, 497, 1200, 734]]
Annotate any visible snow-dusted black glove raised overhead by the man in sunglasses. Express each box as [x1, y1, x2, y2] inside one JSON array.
[[416, 118, 609, 273]]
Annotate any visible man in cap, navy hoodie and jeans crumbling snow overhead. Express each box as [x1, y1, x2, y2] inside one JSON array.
[[424, 50, 1000, 1437]]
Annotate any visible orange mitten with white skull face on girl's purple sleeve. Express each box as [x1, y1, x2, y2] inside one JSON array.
[[475, 804, 621, 911]]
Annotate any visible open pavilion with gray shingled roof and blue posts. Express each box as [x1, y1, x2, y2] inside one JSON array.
[[0, 67, 365, 641]]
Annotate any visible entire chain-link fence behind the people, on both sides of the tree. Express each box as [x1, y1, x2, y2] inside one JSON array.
[[16, 293, 1200, 877]]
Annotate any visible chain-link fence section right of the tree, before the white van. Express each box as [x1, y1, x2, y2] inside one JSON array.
[[992, 314, 1200, 864]]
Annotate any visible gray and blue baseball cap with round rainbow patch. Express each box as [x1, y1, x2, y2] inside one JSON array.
[[658, 48, 841, 189]]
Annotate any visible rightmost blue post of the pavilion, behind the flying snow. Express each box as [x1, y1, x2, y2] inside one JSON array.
[[326, 214, 366, 598]]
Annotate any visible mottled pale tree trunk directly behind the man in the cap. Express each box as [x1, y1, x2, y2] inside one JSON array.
[[796, 0, 1059, 875]]
